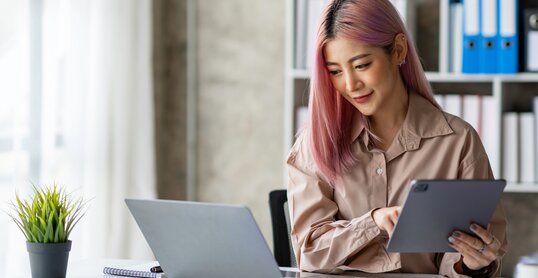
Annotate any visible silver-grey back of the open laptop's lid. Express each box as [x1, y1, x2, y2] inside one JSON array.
[[125, 199, 282, 278]]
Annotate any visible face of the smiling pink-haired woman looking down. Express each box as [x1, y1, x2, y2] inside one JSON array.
[[324, 37, 402, 116]]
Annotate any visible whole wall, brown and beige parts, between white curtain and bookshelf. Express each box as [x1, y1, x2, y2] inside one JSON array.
[[153, 0, 285, 248]]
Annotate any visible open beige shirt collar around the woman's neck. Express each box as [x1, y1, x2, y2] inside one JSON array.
[[351, 92, 454, 156]]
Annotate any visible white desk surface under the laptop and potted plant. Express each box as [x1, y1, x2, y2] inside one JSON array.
[[16, 259, 444, 278]]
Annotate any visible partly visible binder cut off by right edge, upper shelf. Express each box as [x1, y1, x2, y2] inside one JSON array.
[[523, 9, 538, 71]]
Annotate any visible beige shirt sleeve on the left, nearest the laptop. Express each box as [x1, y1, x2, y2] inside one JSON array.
[[287, 133, 388, 273]]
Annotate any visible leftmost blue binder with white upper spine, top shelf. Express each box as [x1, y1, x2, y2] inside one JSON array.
[[462, 0, 480, 73]]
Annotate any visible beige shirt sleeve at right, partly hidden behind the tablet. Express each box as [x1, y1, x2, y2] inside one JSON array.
[[439, 129, 508, 277]]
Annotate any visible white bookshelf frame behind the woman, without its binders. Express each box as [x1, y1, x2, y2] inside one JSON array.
[[284, 0, 538, 193]]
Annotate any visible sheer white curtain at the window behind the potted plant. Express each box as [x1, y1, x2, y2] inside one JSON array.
[[0, 0, 156, 276]]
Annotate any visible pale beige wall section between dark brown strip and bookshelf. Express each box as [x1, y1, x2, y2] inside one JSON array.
[[197, 0, 285, 247]]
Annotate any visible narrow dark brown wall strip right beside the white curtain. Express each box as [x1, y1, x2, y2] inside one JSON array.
[[152, 0, 187, 200]]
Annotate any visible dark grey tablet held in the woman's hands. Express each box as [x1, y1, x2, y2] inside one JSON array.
[[387, 180, 506, 253]]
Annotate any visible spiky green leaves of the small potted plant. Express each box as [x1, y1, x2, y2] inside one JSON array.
[[8, 183, 86, 243]]
